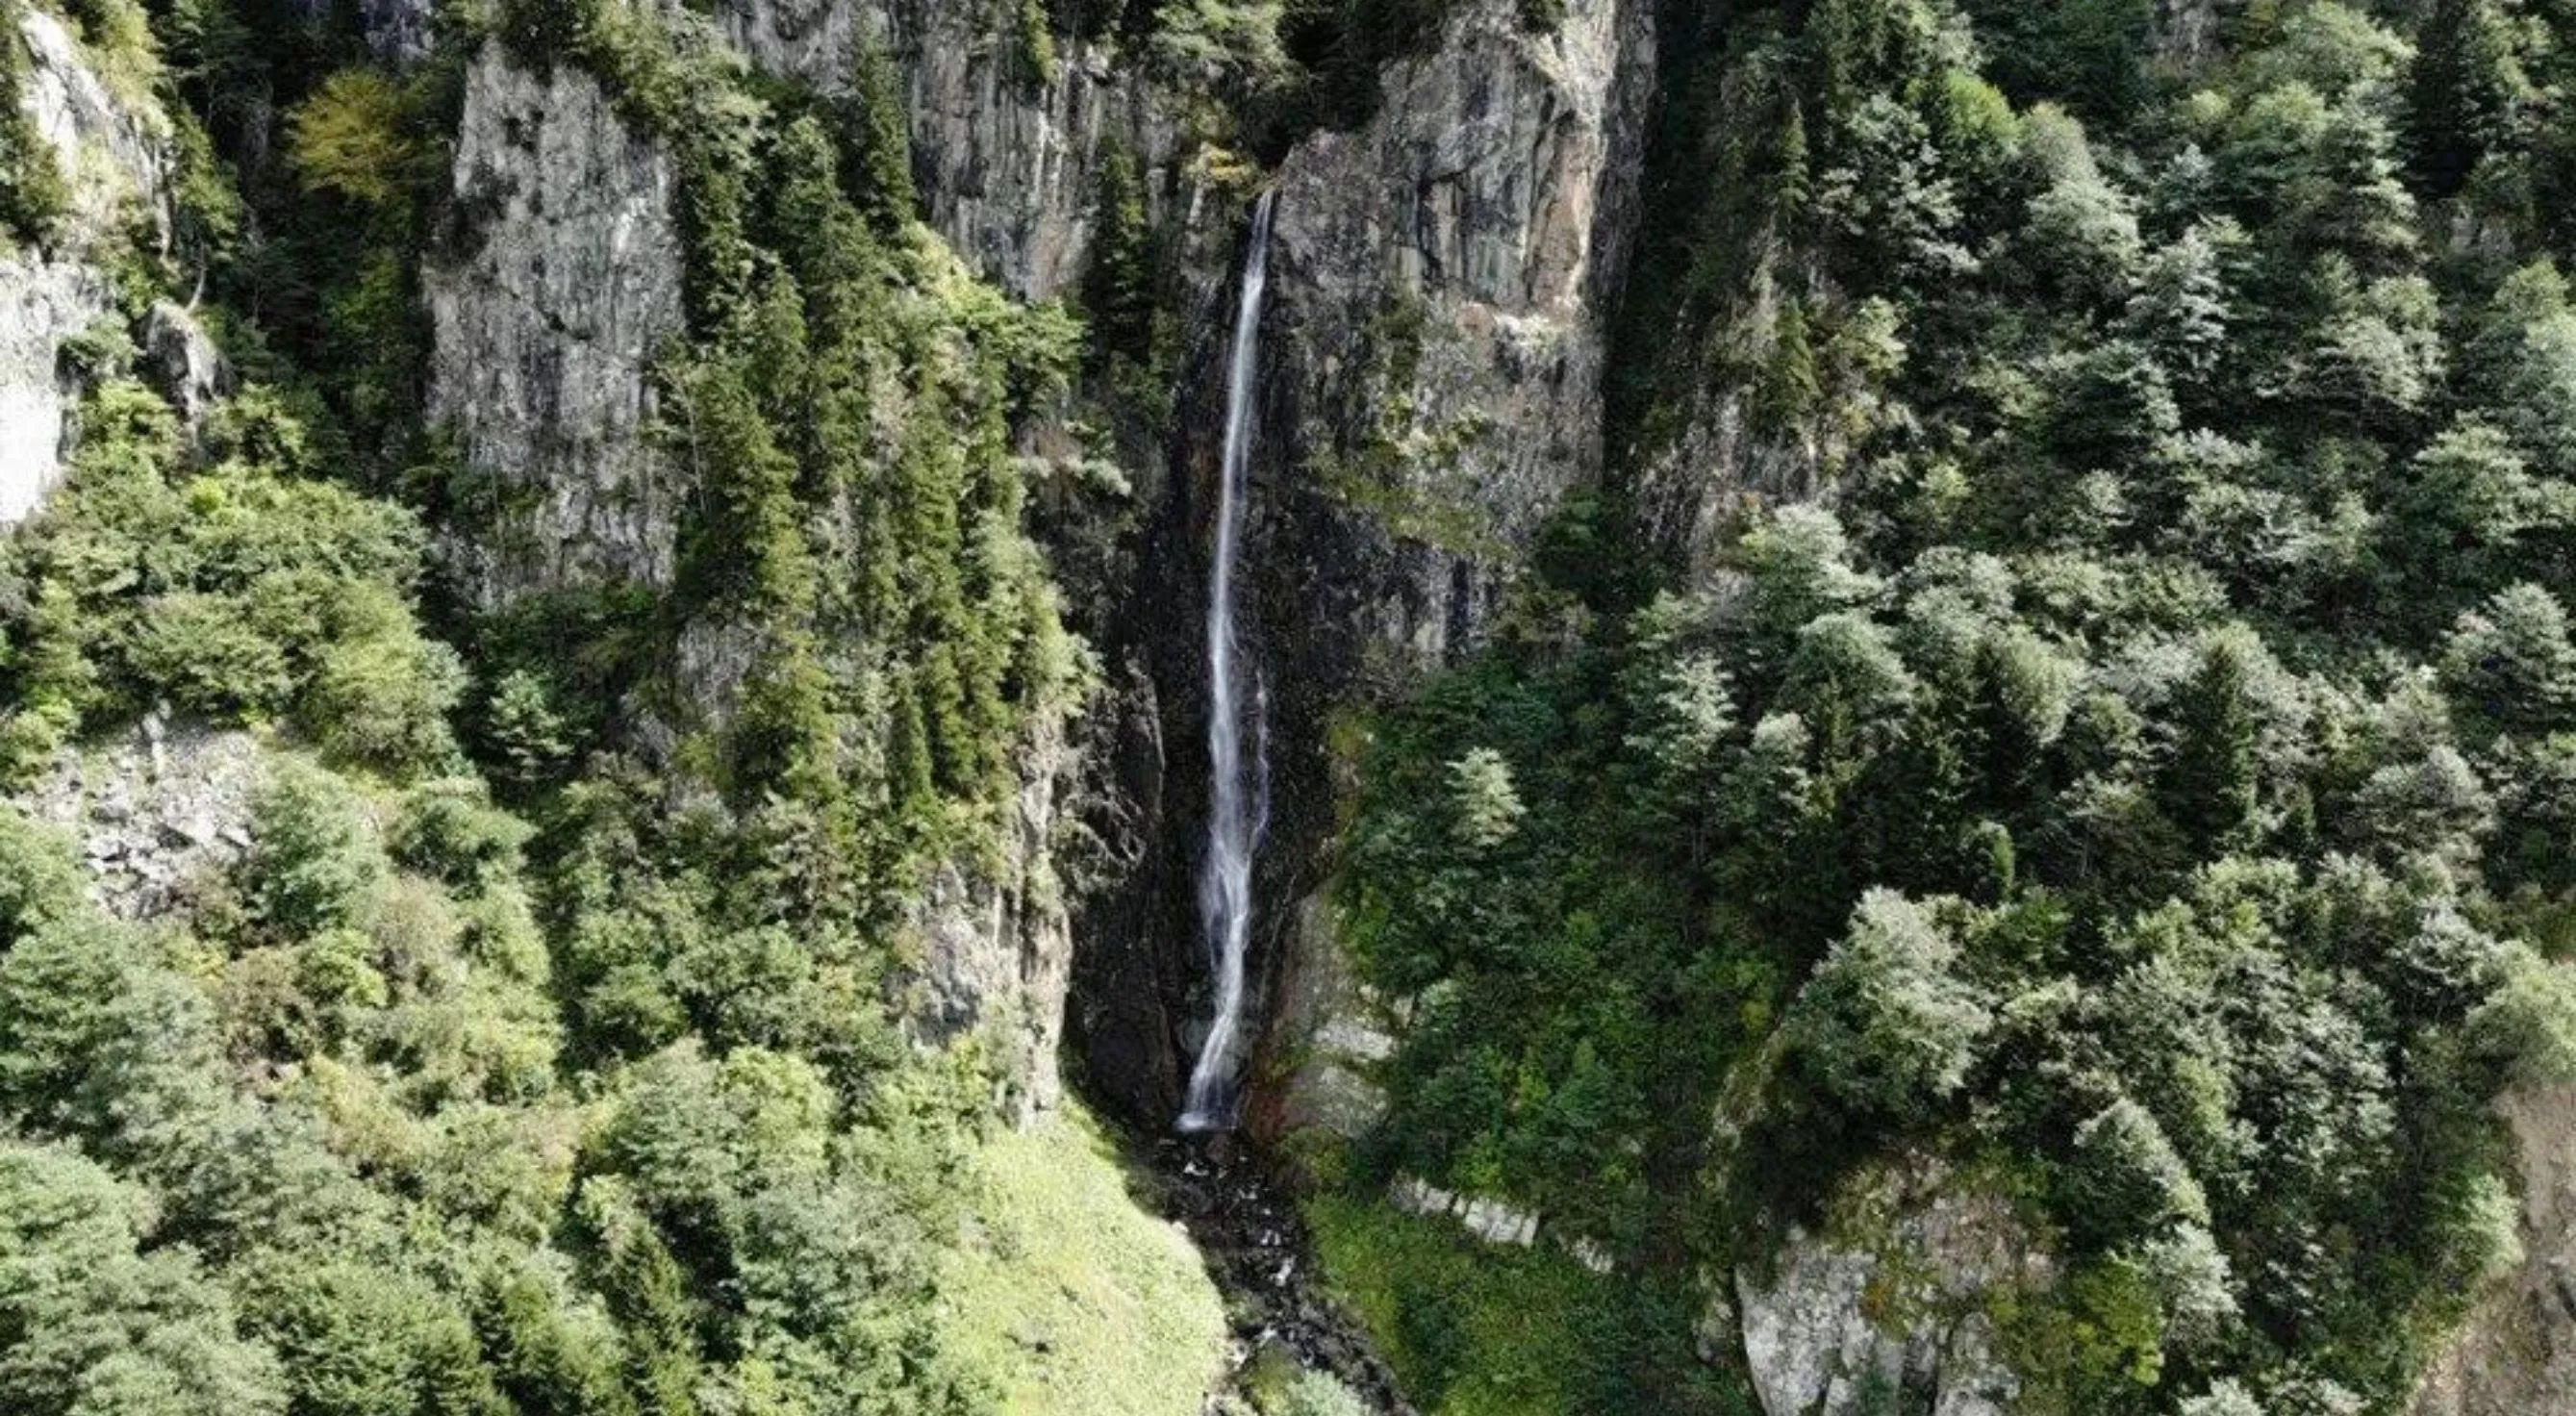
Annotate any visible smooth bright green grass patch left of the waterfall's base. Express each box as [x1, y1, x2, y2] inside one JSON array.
[[948, 1104, 1226, 1416]]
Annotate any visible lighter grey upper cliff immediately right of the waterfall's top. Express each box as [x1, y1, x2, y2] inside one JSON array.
[[1270, 0, 1654, 665]]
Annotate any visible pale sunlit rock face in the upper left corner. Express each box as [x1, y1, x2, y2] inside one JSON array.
[[0, 8, 170, 528]]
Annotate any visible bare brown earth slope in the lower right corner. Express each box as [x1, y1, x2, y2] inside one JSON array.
[[2409, 1086, 2576, 1416]]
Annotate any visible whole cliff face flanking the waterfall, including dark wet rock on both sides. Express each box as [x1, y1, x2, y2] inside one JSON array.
[[1055, 0, 1654, 1138]]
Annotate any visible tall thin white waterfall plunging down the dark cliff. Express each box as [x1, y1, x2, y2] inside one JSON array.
[[1180, 193, 1275, 1130]]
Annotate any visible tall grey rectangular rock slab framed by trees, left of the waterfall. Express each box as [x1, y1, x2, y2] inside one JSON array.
[[425, 43, 683, 608]]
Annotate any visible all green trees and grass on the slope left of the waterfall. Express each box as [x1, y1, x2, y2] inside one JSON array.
[[0, 0, 1224, 1416]]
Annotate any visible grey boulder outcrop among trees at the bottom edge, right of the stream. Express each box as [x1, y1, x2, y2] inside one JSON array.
[[1703, 1161, 2051, 1416]]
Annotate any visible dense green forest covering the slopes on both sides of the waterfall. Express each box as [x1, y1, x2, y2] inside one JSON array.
[[0, 0, 2576, 1416]]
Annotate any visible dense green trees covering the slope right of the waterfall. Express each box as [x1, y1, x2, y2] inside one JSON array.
[[1340, 0, 2576, 1413]]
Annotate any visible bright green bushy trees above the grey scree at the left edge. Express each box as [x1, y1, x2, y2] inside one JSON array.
[[0, 381, 461, 772]]
